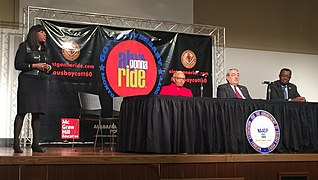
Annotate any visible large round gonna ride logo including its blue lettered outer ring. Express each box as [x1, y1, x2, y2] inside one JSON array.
[[99, 31, 163, 97]]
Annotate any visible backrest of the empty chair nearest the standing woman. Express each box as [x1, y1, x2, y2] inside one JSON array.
[[78, 92, 102, 118]]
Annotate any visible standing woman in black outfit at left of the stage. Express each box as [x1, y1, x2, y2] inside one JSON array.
[[13, 25, 52, 153]]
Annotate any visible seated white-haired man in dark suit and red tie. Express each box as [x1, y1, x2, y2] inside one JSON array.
[[217, 68, 251, 99]]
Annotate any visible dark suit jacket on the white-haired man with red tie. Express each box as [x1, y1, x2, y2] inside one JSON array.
[[217, 83, 251, 99]]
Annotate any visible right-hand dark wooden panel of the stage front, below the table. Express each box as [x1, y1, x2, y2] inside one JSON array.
[[161, 162, 318, 180]]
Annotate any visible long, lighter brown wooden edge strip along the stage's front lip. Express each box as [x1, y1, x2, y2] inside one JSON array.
[[0, 153, 318, 165]]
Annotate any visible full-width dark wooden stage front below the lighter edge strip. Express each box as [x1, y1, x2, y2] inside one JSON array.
[[0, 162, 318, 180]]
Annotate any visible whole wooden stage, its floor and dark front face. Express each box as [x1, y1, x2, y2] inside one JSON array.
[[0, 145, 318, 180]]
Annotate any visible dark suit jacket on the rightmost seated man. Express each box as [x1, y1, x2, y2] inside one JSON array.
[[267, 80, 300, 101]]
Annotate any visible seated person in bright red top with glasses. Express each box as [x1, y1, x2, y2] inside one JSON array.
[[160, 71, 193, 97]]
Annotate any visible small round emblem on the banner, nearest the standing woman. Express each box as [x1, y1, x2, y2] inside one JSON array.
[[62, 42, 81, 61]]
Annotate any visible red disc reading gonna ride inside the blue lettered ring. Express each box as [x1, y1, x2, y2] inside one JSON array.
[[106, 40, 157, 96]]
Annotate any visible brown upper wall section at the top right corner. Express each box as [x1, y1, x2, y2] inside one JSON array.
[[194, 0, 318, 54]]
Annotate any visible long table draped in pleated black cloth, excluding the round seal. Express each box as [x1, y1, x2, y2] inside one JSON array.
[[117, 95, 318, 153]]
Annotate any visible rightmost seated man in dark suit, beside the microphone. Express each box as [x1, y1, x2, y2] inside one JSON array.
[[267, 68, 306, 102]]
